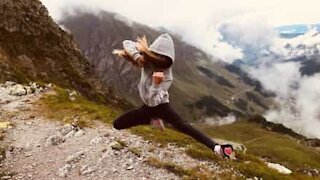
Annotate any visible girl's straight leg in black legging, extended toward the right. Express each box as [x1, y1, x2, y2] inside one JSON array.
[[158, 104, 216, 149]]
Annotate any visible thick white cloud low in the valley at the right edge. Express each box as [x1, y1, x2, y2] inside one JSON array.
[[265, 71, 320, 138]]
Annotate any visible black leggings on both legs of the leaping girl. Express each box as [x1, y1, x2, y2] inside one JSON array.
[[113, 103, 216, 149]]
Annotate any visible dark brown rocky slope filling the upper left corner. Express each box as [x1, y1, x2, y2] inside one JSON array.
[[0, 0, 117, 102]]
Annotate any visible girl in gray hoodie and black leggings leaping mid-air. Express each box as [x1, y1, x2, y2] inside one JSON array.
[[113, 34, 233, 158]]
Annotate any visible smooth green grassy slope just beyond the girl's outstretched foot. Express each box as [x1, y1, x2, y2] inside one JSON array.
[[200, 121, 320, 169]]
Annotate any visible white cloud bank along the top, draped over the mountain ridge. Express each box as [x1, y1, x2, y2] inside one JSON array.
[[41, 0, 320, 62]]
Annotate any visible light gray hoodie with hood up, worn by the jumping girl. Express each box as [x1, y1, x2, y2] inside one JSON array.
[[123, 34, 175, 107]]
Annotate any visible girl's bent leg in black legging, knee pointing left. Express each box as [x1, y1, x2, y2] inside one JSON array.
[[113, 106, 151, 130]]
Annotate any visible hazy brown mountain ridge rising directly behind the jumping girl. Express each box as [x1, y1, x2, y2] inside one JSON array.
[[60, 12, 271, 120]]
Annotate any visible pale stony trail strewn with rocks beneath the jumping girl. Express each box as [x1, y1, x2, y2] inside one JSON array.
[[0, 83, 226, 179]]
